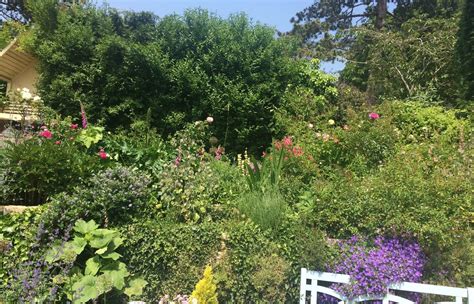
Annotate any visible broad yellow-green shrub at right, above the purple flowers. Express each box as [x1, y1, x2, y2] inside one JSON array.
[[313, 144, 472, 285]]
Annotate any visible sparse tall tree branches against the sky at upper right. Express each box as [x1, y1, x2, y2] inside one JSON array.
[[291, 0, 459, 59]]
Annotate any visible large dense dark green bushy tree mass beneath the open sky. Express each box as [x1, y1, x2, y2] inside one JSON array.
[[30, 7, 320, 151]]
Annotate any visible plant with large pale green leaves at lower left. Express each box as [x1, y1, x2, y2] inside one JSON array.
[[44, 219, 147, 303]]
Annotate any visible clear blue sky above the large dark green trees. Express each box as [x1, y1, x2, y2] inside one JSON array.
[[103, 0, 342, 73]]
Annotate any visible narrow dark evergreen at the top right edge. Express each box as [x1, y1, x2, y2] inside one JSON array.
[[457, 0, 474, 100]]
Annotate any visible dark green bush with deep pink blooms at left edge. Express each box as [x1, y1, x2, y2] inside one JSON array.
[[0, 135, 100, 205]]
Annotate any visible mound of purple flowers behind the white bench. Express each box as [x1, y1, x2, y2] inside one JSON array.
[[328, 237, 425, 299]]
